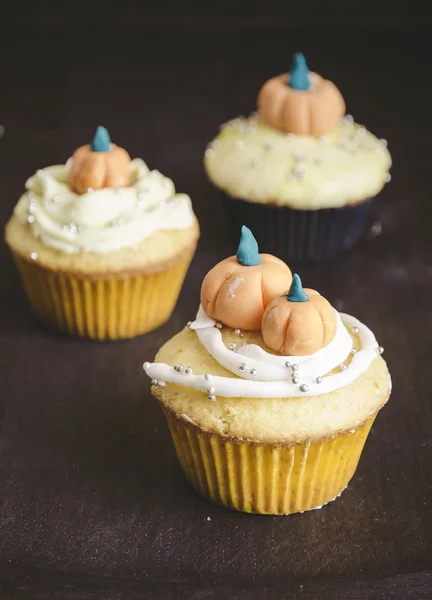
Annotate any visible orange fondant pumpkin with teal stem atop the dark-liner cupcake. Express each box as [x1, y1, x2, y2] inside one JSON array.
[[258, 54, 345, 136]]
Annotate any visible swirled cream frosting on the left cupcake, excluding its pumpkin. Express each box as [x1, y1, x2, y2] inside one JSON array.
[[14, 159, 195, 254]]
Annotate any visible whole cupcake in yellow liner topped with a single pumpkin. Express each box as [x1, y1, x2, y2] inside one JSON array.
[[6, 127, 199, 340]]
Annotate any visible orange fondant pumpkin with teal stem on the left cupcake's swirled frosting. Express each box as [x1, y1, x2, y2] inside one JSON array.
[[69, 127, 131, 194]]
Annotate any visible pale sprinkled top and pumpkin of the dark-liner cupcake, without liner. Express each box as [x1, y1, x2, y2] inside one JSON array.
[[204, 55, 391, 209]]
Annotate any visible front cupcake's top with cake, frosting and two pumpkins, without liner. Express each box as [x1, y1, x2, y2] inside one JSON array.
[[144, 227, 391, 442]]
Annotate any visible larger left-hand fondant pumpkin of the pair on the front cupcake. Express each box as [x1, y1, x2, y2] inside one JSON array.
[[201, 226, 292, 330]]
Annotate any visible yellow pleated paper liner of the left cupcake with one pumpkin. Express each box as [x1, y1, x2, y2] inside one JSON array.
[[14, 254, 192, 340]]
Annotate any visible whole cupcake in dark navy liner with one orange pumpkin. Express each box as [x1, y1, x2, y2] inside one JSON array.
[[204, 54, 391, 260]]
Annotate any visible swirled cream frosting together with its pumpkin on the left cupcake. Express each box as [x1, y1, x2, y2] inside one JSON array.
[[10, 127, 196, 255]]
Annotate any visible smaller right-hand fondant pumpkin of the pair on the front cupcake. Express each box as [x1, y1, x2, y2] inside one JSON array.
[[262, 274, 336, 356]]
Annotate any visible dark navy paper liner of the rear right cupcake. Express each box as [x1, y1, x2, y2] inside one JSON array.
[[223, 194, 372, 261]]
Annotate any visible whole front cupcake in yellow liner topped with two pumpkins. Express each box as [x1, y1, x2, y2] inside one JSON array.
[[144, 228, 391, 515]]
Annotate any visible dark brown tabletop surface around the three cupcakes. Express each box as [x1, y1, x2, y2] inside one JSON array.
[[0, 16, 432, 600]]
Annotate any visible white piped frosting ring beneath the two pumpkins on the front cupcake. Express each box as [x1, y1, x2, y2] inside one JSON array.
[[144, 307, 378, 398]]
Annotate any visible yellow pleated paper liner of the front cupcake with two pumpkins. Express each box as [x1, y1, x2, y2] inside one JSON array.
[[164, 410, 375, 515]]
